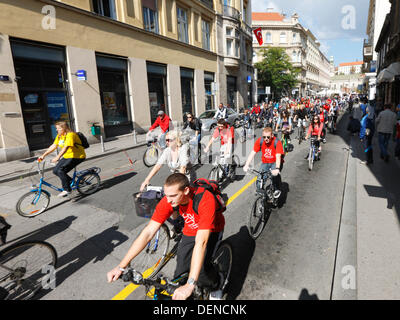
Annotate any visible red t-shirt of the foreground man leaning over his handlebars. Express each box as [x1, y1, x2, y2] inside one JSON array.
[[151, 188, 225, 236]]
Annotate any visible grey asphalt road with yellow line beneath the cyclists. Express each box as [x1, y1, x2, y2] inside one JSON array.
[[0, 117, 347, 300]]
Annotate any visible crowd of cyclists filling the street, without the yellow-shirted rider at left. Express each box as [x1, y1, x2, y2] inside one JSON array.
[[107, 98, 343, 299]]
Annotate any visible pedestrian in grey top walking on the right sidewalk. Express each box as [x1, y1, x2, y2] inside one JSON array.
[[375, 104, 397, 162]]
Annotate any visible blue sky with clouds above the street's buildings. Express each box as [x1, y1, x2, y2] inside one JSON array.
[[251, 0, 369, 66]]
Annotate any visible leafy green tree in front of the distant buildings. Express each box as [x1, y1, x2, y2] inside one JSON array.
[[254, 48, 301, 96]]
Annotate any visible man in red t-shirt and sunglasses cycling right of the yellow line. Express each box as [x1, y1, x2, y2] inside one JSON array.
[[243, 127, 284, 198]]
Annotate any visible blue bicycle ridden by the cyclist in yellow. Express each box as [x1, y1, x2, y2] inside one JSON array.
[[16, 160, 101, 218]]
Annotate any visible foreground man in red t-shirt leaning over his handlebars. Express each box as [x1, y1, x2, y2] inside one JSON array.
[[107, 173, 225, 300]]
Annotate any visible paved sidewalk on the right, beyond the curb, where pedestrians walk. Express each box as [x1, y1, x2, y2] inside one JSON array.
[[351, 135, 400, 300]]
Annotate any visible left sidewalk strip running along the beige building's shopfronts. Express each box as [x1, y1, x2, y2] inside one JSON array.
[[0, 134, 146, 183]]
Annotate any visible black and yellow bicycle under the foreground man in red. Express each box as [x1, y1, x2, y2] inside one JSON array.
[[122, 240, 233, 300]]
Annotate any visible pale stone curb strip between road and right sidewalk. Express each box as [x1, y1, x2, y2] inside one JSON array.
[[331, 138, 357, 300]]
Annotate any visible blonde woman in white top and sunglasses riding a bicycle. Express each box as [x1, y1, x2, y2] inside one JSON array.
[[140, 130, 196, 191]]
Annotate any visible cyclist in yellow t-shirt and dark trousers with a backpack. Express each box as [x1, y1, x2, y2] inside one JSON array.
[[38, 121, 86, 197]]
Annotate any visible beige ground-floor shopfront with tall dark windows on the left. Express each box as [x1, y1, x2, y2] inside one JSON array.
[[0, 2, 220, 162]]
